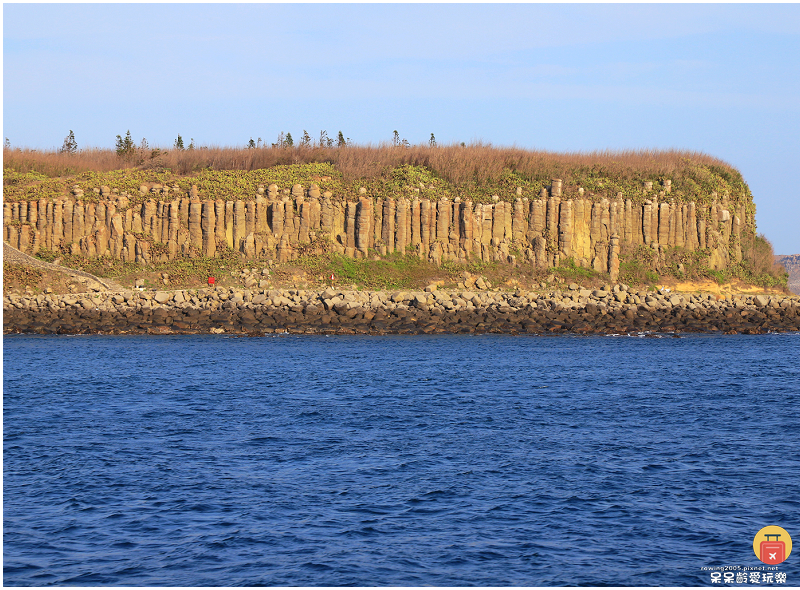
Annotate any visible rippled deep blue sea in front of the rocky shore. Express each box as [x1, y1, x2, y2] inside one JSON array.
[[3, 335, 800, 586]]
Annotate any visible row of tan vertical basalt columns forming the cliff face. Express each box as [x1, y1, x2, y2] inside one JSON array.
[[3, 180, 754, 279]]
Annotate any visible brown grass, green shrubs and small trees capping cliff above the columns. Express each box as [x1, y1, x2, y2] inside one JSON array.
[[4, 145, 752, 209]]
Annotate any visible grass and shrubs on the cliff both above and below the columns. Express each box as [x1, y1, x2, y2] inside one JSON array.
[[3, 144, 786, 296]]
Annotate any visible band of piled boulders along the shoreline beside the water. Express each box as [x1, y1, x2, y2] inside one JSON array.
[[3, 284, 800, 335]]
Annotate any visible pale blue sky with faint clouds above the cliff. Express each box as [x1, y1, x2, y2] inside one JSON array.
[[3, 4, 800, 254]]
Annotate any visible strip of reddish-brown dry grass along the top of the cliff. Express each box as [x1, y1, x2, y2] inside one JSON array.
[[3, 143, 738, 186]]
